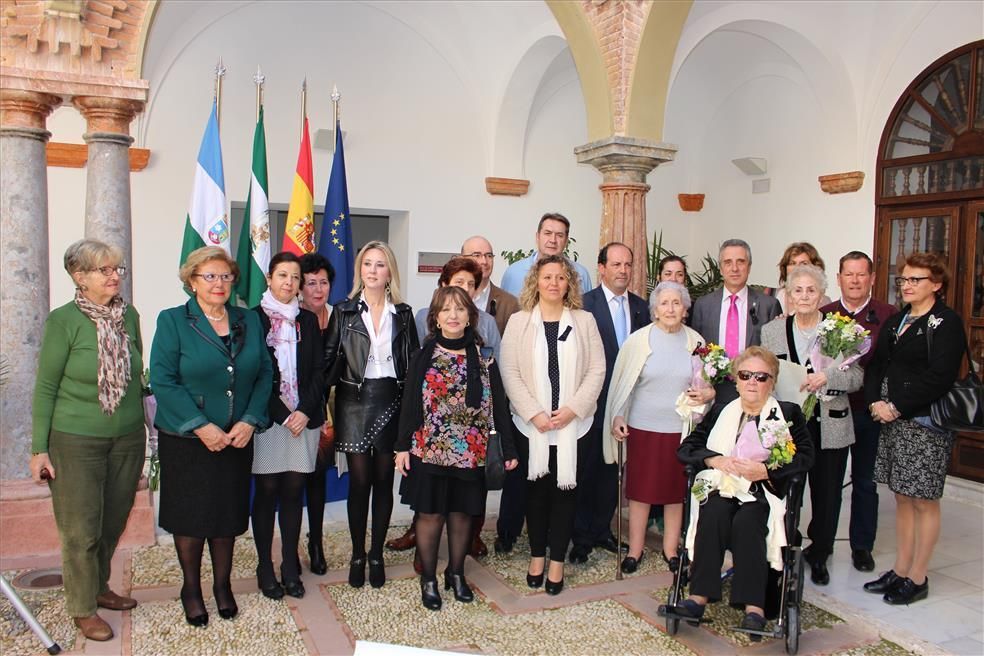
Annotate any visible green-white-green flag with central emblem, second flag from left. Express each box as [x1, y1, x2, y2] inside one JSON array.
[[236, 106, 270, 307]]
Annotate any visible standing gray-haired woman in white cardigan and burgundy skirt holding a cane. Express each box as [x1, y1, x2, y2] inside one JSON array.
[[604, 281, 714, 574]]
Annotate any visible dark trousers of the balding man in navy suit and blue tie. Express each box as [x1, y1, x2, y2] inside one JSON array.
[[574, 426, 618, 549]]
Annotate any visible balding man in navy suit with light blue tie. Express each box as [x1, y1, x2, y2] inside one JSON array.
[[569, 242, 650, 563]]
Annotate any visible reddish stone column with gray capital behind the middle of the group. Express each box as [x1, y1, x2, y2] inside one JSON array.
[[574, 135, 676, 297]]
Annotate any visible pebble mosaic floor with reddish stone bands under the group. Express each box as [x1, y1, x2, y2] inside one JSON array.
[[0, 526, 916, 656]]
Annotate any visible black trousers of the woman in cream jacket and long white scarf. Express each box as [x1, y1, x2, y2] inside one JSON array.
[[532, 438, 577, 562]]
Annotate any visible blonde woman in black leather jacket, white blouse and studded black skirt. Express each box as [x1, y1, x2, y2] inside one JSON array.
[[325, 241, 420, 588]]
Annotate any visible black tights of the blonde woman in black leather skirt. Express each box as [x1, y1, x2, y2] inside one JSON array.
[[346, 449, 395, 560]]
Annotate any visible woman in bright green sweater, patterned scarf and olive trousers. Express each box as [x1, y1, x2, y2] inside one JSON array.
[[31, 239, 146, 640]]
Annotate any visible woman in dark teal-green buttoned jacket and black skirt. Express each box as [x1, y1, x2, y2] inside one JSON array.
[[150, 246, 273, 626]]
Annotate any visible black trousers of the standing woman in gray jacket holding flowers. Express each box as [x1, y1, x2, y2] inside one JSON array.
[[806, 418, 850, 561]]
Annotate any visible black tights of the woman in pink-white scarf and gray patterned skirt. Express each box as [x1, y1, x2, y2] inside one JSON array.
[[253, 472, 307, 582]]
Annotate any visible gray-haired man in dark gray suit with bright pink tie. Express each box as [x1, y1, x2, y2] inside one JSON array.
[[690, 239, 782, 405]]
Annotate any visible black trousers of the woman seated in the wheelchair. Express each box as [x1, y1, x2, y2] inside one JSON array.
[[690, 494, 769, 608]]
